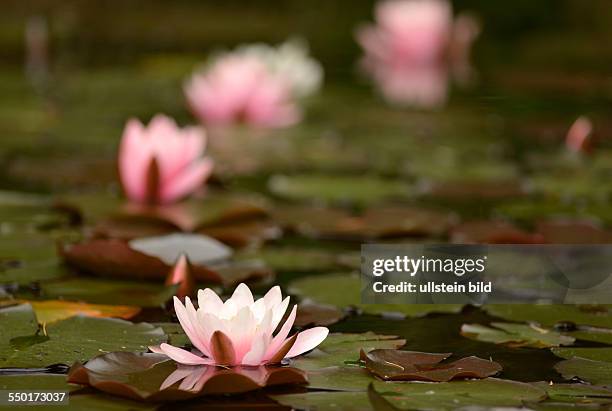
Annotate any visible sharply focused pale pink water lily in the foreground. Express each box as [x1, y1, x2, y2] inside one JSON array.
[[149, 284, 329, 366]]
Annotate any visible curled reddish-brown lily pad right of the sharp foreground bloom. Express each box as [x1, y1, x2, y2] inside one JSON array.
[[361, 349, 502, 382]]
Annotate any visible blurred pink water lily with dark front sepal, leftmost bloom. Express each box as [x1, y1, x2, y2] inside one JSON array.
[[119, 114, 213, 204]]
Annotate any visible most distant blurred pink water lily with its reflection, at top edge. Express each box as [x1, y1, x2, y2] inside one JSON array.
[[357, 0, 480, 108]]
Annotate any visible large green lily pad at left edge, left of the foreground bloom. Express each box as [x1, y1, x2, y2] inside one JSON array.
[[0, 304, 166, 368]]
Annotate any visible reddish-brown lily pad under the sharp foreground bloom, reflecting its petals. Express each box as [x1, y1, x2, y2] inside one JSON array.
[[68, 352, 308, 402]]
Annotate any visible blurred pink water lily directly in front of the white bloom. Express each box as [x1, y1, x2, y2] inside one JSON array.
[[185, 53, 301, 127]]
